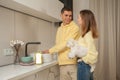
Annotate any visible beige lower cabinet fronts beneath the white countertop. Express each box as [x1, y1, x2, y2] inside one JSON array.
[[19, 65, 59, 80]]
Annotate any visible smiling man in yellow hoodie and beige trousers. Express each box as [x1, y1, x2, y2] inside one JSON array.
[[42, 7, 80, 80]]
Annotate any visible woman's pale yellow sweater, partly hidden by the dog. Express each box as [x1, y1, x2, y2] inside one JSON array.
[[78, 31, 98, 64]]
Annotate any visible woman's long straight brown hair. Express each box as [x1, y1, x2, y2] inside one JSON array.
[[80, 10, 98, 38]]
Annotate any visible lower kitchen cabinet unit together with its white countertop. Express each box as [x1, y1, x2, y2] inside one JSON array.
[[0, 60, 59, 80]]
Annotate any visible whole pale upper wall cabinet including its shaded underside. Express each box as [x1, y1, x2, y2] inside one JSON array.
[[0, 0, 64, 22]]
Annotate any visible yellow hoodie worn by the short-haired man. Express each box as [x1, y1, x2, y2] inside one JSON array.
[[49, 21, 80, 65]]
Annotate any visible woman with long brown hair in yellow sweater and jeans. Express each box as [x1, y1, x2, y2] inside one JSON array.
[[77, 10, 98, 80]]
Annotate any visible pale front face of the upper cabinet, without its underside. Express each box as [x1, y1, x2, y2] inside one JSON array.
[[14, 0, 63, 20]]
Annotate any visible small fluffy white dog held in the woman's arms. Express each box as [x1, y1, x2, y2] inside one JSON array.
[[67, 39, 95, 72]]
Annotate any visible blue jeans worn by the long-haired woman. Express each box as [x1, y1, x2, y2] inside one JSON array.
[[77, 61, 93, 80]]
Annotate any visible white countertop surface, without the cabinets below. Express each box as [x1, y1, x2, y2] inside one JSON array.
[[0, 61, 58, 80]]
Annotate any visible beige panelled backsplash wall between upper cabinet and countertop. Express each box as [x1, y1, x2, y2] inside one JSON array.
[[0, 7, 57, 65]]
